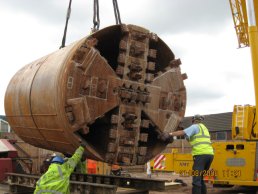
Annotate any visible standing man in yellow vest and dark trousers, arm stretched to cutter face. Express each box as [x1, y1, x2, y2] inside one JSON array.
[[160, 114, 214, 194]]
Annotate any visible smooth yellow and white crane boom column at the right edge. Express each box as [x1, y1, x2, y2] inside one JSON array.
[[246, 0, 258, 133]]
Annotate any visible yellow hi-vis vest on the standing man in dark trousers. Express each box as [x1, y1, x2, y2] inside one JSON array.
[[189, 123, 214, 156]]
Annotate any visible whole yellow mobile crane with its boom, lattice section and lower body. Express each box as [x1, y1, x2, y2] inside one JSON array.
[[152, 0, 258, 187]]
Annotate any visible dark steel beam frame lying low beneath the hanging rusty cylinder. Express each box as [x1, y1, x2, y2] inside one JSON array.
[[3, 173, 180, 194]]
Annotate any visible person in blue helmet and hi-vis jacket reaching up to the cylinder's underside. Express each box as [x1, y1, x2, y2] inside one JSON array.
[[34, 144, 86, 194]]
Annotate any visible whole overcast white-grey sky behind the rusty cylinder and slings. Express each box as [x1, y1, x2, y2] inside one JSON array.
[[0, 0, 254, 116]]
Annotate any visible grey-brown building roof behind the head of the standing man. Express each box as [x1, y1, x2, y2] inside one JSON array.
[[179, 112, 232, 131]]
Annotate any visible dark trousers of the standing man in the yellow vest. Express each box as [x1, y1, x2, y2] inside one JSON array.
[[192, 154, 213, 194]]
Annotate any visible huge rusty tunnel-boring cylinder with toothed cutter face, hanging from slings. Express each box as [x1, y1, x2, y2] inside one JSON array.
[[5, 24, 186, 165]]
